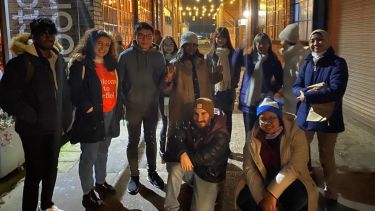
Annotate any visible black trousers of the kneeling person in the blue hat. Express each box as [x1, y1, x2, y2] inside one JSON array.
[[237, 180, 308, 211]]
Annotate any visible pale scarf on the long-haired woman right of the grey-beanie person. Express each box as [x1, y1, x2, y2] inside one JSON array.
[[215, 47, 232, 93]]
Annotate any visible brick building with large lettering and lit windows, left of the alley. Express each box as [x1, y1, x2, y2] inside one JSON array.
[[0, 0, 162, 63]]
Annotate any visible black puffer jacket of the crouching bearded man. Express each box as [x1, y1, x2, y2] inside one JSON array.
[[164, 111, 230, 182]]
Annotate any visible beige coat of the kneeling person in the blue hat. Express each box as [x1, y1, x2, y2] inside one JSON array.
[[235, 113, 318, 211]]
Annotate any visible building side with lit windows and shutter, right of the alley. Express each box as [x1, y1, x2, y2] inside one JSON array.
[[238, 0, 375, 133]]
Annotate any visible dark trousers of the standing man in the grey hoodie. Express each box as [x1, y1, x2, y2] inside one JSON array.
[[126, 106, 158, 176]]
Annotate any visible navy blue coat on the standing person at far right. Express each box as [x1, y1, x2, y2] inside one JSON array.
[[293, 48, 348, 133]]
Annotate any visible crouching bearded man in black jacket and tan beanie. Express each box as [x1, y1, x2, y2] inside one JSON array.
[[164, 98, 229, 211]]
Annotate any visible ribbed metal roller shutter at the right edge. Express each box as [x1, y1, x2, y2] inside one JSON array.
[[330, 0, 375, 132]]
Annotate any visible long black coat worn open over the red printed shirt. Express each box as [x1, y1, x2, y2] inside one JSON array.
[[69, 58, 122, 143]]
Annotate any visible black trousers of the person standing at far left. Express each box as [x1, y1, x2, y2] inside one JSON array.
[[20, 134, 61, 211]]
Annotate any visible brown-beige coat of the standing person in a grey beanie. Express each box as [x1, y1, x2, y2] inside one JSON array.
[[163, 58, 212, 136]]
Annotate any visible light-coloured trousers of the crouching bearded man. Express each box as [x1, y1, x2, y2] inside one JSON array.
[[164, 162, 219, 211]]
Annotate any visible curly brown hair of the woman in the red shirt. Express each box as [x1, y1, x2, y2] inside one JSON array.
[[72, 28, 117, 71]]
